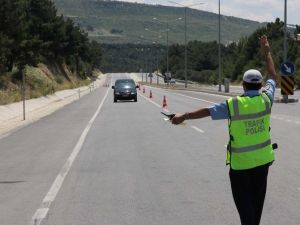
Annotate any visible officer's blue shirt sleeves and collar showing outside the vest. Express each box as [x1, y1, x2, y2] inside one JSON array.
[[208, 79, 276, 120]]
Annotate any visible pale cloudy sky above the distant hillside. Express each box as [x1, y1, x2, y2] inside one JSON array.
[[122, 0, 300, 24]]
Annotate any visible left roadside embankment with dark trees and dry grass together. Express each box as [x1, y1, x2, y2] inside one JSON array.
[[0, 0, 102, 104]]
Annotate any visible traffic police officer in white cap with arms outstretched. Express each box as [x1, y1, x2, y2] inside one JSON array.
[[172, 35, 277, 225]]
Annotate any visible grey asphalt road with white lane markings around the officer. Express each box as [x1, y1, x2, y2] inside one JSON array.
[[0, 74, 300, 225]]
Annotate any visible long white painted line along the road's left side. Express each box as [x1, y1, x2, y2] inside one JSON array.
[[30, 81, 110, 225]]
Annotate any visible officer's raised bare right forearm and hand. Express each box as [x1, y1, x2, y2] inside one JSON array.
[[260, 35, 277, 81]]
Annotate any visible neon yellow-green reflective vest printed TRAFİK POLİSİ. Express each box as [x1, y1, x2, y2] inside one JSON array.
[[226, 93, 275, 170]]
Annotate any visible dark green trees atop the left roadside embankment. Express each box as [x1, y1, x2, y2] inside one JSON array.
[[0, 0, 102, 80]]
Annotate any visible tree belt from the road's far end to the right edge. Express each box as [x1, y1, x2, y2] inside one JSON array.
[[103, 19, 300, 87]]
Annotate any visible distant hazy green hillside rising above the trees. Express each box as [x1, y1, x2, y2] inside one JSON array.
[[53, 0, 263, 44]]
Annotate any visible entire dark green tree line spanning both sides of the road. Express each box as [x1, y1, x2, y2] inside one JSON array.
[[0, 0, 300, 90]]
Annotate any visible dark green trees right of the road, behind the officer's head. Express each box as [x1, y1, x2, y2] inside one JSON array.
[[164, 19, 300, 86]]
